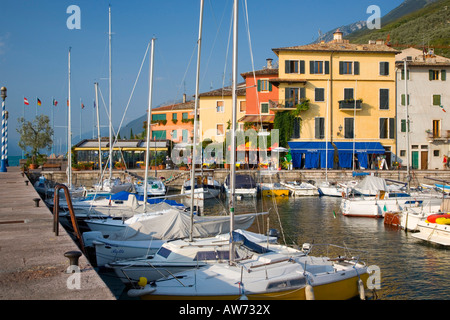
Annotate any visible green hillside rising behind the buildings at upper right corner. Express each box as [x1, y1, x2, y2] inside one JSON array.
[[347, 0, 450, 58]]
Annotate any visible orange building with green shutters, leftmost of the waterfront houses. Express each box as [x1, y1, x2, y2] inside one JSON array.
[[151, 95, 194, 143]]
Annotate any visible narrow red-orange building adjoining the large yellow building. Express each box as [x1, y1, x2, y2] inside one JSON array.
[[238, 59, 279, 131]]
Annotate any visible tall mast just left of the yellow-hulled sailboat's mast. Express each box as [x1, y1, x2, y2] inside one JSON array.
[[189, 0, 203, 241]]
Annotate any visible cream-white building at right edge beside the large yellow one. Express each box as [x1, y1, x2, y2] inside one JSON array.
[[396, 48, 450, 170]]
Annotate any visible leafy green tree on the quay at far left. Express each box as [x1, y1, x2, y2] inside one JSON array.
[[16, 115, 53, 164]]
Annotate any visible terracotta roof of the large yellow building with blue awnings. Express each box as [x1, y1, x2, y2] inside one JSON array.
[[272, 42, 400, 55]]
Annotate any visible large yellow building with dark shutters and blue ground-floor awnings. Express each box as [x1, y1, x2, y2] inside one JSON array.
[[271, 31, 399, 169]]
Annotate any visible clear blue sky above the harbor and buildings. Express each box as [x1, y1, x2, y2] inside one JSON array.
[[0, 0, 403, 155]]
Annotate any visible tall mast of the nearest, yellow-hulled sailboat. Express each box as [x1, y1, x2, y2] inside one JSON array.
[[230, 0, 238, 264]]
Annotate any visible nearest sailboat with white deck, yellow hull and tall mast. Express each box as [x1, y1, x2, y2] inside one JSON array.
[[128, 0, 368, 300]]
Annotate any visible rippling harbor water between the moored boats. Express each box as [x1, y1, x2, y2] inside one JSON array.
[[103, 192, 450, 300]]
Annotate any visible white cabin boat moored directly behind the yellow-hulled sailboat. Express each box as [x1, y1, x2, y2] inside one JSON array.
[[107, 229, 280, 284]]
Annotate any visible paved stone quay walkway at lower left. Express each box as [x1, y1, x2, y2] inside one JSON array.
[[0, 167, 116, 300]]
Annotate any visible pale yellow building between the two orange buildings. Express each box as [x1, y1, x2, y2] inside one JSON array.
[[199, 83, 245, 142]]
